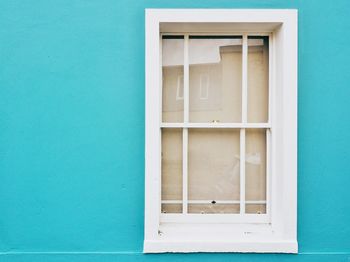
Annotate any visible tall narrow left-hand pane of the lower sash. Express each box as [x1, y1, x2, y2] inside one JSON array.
[[162, 129, 182, 207]]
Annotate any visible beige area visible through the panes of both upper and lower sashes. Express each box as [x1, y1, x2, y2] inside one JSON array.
[[162, 37, 269, 213]]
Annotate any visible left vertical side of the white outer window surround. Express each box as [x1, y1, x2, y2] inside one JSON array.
[[145, 12, 162, 241]]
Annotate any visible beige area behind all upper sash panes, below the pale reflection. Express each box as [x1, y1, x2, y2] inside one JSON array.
[[162, 39, 269, 123]]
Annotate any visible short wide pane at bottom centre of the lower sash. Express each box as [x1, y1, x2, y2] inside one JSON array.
[[188, 204, 239, 214]]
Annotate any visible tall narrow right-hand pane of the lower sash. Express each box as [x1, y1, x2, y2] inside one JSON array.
[[245, 129, 266, 205]]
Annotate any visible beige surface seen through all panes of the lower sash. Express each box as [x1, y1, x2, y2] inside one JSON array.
[[162, 129, 266, 213]]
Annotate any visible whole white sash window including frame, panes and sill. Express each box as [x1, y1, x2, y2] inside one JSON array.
[[144, 9, 297, 253]]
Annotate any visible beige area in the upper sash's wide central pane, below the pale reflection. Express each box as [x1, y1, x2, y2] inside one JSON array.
[[190, 47, 242, 123]]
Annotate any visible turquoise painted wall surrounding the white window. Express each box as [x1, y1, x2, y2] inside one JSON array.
[[0, 0, 350, 262]]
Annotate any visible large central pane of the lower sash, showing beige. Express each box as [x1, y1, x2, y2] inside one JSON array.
[[188, 129, 240, 213]]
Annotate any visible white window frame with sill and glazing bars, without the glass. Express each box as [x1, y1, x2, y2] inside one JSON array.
[[144, 9, 298, 253]]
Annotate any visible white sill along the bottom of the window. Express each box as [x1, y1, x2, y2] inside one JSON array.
[[144, 223, 298, 253]]
